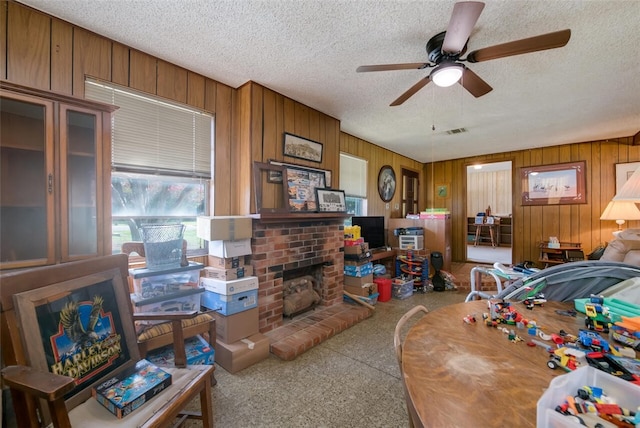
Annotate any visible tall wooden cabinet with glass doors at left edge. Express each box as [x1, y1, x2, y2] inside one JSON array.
[[0, 82, 114, 269]]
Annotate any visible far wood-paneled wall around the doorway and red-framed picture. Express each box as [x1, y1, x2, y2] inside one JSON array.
[[424, 137, 640, 263]]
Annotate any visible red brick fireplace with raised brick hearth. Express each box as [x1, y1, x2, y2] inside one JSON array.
[[250, 213, 372, 361]]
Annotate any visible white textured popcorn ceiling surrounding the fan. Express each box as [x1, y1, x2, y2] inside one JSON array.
[[20, 0, 640, 162]]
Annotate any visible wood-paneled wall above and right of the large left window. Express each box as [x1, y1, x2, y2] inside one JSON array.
[[0, 0, 238, 215]]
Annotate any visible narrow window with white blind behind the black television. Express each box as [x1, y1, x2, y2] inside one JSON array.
[[340, 153, 367, 219]]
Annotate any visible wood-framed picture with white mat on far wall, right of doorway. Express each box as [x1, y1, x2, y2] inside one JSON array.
[[520, 161, 587, 205]]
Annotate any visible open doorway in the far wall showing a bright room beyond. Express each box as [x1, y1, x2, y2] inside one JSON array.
[[466, 161, 513, 265]]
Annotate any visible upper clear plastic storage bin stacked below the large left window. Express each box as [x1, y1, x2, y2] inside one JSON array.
[[129, 262, 204, 299]]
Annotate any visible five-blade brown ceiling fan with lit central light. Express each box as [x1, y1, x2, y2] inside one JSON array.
[[356, 1, 571, 106]]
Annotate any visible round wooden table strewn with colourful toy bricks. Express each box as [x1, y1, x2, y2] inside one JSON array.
[[402, 300, 584, 428]]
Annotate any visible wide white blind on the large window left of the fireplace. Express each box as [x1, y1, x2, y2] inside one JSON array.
[[85, 79, 213, 179]]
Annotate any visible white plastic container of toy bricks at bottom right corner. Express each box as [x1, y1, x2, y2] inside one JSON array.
[[536, 366, 640, 428]]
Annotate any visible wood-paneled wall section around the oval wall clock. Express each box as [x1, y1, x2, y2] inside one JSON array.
[[340, 132, 426, 220]]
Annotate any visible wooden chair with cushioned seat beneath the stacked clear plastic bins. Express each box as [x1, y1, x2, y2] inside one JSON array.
[[122, 240, 216, 374]]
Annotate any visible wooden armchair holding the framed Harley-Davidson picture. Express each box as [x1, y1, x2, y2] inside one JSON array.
[[0, 254, 213, 428]]
